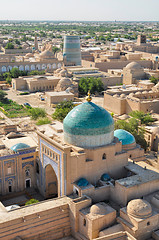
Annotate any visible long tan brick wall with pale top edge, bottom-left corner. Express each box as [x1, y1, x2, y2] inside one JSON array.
[[0, 197, 71, 240]]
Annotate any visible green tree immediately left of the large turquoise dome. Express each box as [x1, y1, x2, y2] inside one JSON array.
[[52, 101, 74, 122]]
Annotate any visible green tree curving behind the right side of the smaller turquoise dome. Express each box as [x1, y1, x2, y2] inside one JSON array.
[[115, 118, 148, 151]]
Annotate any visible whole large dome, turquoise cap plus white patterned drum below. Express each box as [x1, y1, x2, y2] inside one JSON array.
[[63, 102, 114, 148]]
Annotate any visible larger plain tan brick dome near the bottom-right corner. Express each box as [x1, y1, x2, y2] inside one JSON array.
[[127, 199, 152, 218]]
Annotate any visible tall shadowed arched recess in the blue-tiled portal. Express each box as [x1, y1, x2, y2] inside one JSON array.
[[45, 164, 58, 198]]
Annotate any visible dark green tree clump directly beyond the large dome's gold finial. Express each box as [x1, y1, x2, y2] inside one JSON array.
[[78, 77, 104, 95]]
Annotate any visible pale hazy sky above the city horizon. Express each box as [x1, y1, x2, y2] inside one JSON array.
[[0, 0, 159, 21]]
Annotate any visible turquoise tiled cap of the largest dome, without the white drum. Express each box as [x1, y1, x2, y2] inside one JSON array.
[[63, 102, 114, 136]]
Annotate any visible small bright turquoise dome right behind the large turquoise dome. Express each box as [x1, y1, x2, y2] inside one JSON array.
[[114, 129, 135, 145]]
